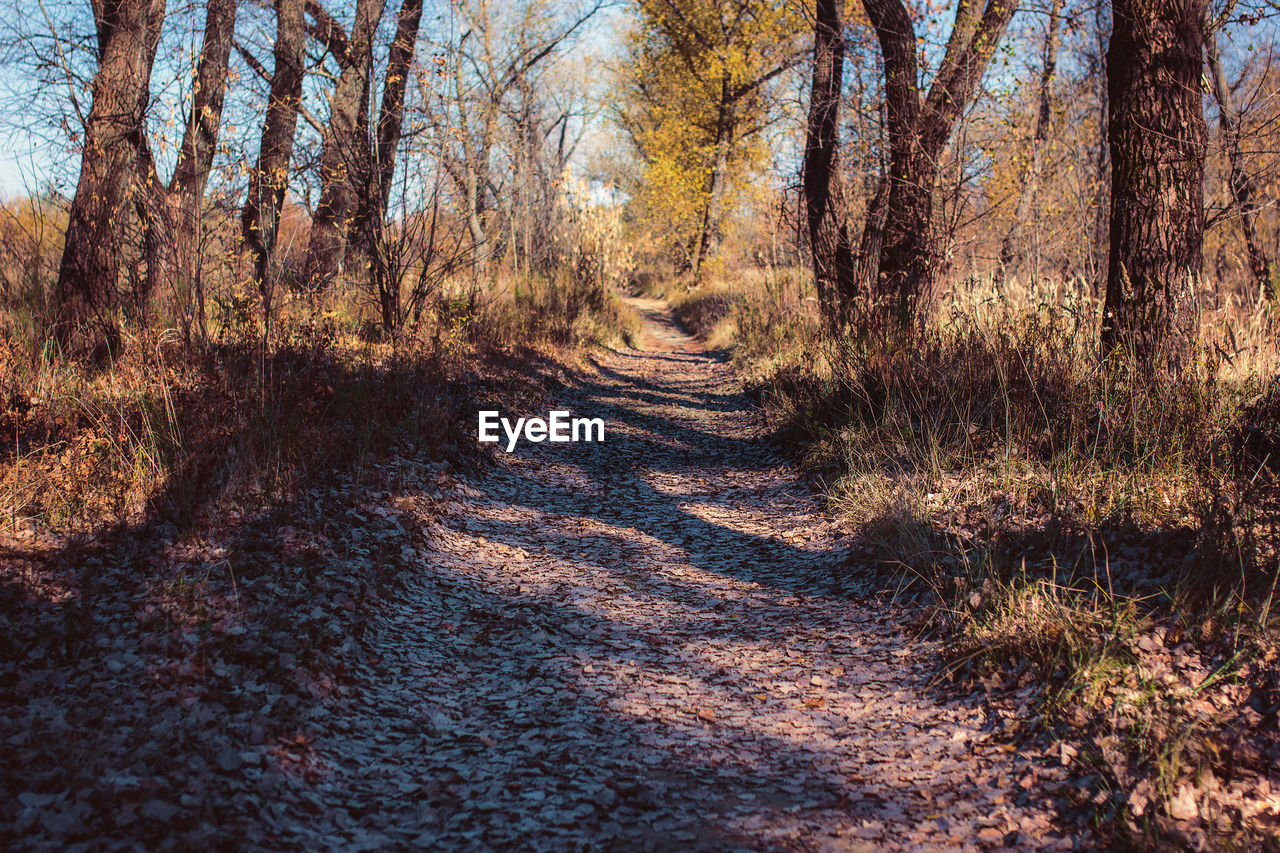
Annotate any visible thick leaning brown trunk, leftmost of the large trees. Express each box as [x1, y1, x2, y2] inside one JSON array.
[[54, 0, 165, 353]]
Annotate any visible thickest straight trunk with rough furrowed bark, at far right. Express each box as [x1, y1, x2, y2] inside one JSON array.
[[1102, 0, 1206, 370]]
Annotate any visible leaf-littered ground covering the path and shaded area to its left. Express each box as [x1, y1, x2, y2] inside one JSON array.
[[0, 300, 1100, 850]]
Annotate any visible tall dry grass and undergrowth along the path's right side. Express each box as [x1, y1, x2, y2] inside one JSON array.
[[677, 266, 1280, 847]]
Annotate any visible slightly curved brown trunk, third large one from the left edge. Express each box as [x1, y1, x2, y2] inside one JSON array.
[[241, 0, 306, 327]]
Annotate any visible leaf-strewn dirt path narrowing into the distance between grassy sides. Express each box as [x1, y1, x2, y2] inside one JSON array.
[[264, 301, 1089, 850]]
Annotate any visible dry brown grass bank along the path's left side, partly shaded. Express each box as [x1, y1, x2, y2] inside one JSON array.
[[0, 267, 637, 537]]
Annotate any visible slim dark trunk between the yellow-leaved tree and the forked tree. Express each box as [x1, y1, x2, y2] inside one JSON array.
[[804, 0, 856, 330]]
